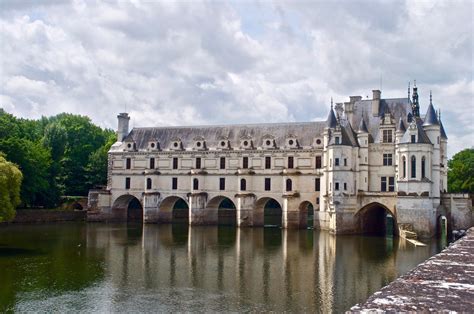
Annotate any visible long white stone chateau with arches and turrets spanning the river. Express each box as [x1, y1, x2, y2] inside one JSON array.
[[89, 87, 470, 237]]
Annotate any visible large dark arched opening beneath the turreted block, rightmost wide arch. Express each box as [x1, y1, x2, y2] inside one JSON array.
[[356, 202, 398, 237]]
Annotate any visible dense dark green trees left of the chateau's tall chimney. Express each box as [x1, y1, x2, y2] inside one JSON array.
[[0, 109, 115, 207]]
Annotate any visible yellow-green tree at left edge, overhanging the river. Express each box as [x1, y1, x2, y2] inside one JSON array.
[[0, 154, 23, 222]]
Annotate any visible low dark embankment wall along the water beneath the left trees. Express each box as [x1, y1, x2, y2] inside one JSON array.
[[3, 209, 87, 224]]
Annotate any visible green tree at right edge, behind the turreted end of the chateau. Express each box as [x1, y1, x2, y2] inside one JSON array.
[[448, 148, 474, 193]]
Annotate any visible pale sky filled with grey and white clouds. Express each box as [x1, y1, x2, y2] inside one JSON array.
[[0, 0, 474, 156]]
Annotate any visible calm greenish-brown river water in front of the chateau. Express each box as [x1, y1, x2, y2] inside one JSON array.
[[0, 223, 440, 313]]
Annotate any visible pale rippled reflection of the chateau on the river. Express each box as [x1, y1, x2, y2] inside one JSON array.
[[87, 225, 438, 313]]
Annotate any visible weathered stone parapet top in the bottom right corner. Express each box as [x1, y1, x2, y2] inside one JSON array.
[[350, 228, 474, 312]]
